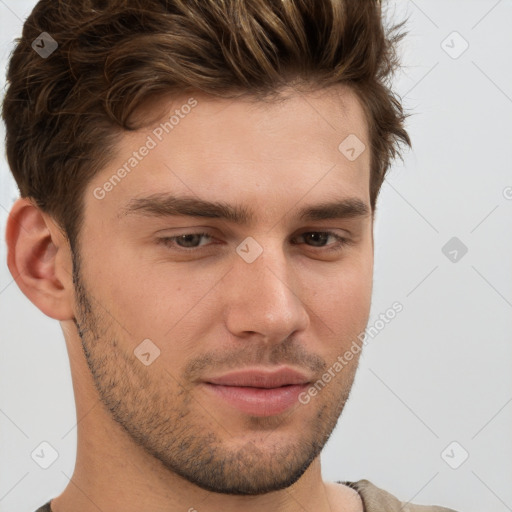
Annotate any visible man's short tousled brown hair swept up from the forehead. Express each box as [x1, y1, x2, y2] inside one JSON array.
[[2, 0, 411, 253]]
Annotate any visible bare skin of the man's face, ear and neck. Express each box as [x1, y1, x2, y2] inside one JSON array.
[[6, 86, 373, 512]]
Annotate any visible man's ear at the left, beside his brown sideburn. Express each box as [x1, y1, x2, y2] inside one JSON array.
[[5, 198, 74, 320]]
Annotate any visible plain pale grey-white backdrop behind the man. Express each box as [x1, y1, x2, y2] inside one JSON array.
[[0, 0, 512, 512]]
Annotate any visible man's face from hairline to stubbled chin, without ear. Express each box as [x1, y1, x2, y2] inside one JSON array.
[[75, 85, 373, 494]]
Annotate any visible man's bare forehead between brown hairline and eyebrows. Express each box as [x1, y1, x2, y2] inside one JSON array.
[[86, 83, 370, 221]]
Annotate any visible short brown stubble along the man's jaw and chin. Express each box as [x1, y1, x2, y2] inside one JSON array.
[[73, 252, 357, 495]]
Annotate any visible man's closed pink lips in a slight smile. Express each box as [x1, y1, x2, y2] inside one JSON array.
[[203, 368, 311, 417]]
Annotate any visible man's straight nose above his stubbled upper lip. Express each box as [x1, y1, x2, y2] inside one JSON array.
[[224, 240, 309, 343]]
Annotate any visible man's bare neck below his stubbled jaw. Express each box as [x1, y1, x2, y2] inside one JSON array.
[[51, 418, 336, 512]]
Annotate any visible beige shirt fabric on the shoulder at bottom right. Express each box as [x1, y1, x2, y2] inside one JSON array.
[[338, 480, 456, 512]]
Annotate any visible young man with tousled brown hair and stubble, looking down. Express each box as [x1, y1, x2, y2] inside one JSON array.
[[3, 0, 458, 512]]
